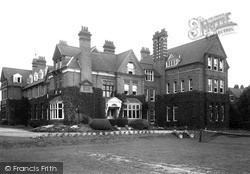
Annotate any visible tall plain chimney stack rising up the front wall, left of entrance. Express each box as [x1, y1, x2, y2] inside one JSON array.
[[78, 27, 93, 93]]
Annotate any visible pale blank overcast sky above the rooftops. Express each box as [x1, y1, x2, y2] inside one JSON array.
[[0, 0, 250, 87]]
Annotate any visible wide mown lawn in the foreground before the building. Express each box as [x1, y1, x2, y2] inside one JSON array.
[[0, 134, 250, 174]]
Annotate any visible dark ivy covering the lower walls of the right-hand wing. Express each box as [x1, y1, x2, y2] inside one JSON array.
[[155, 91, 229, 129]]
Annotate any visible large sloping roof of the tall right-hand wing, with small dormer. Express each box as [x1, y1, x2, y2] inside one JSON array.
[[168, 35, 227, 66]]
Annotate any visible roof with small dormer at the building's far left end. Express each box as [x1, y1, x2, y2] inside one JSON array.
[[1, 67, 32, 87]]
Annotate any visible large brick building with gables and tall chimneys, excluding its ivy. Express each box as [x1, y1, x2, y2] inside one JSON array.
[[1, 27, 229, 126]]
